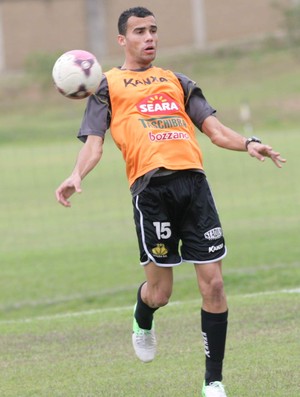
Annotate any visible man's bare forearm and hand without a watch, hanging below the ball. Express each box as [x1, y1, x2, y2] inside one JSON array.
[[55, 135, 103, 207]]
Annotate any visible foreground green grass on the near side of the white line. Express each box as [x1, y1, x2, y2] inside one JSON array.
[[0, 292, 300, 397]]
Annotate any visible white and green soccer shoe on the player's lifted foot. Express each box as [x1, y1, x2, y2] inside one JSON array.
[[132, 305, 156, 363]]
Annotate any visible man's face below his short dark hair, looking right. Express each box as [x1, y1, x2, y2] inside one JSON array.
[[118, 15, 158, 69]]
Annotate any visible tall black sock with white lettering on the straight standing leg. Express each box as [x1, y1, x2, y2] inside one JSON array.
[[201, 309, 228, 385]]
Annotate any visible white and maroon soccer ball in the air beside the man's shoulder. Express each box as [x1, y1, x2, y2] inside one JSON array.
[[52, 50, 102, 99]]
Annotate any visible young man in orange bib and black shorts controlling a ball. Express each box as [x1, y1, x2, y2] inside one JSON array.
[[56, 7, 285, 397]]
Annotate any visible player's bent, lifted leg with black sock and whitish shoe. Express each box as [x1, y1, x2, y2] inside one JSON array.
[[132, 262, 173, 362]]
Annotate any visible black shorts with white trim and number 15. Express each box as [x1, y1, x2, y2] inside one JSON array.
[[133, 171, 226, 266]]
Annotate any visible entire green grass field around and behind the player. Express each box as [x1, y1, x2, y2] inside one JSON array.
[[0, 44, 300, 397]]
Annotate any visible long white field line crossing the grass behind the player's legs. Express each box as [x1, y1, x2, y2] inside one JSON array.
[[0, 287, 300, 326]]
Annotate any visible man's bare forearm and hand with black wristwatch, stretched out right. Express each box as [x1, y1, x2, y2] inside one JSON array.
[[202, 116, 286, 168]]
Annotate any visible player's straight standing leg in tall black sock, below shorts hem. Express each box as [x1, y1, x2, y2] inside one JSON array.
[[195, 261, 228, 396]]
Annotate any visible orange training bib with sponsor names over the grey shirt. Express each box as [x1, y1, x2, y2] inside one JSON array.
[[105, 67, 203, 185]]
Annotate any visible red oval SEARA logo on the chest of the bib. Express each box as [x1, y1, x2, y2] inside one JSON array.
[[136, 93, 180, 116]]
